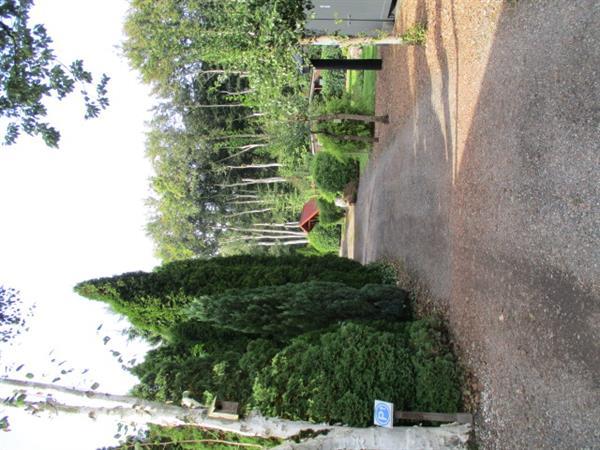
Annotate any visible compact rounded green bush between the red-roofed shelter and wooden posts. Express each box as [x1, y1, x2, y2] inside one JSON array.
[[312, 152, 358, 193]]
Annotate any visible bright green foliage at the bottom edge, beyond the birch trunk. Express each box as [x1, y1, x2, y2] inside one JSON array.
[[102, 424, 280, 450]]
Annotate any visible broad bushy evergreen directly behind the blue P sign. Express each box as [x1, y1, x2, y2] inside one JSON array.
[[252, 321, 460, 426]]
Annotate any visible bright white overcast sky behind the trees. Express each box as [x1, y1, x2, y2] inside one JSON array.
[[0, 0, 158, 450]]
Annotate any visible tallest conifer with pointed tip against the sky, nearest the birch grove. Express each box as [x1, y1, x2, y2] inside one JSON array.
[[75, 255, 390, 334]]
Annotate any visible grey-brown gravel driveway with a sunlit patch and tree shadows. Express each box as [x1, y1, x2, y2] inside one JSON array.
[[354, 0, 600, 449]]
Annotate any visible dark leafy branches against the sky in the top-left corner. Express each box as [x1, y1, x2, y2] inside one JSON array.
[[0, 0, 109, 147]]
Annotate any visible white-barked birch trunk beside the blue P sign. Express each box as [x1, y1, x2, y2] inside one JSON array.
[[0, 378, 470, 450]]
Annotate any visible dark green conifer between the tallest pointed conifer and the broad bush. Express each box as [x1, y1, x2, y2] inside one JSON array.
[[189, 281, 411, 342]]
